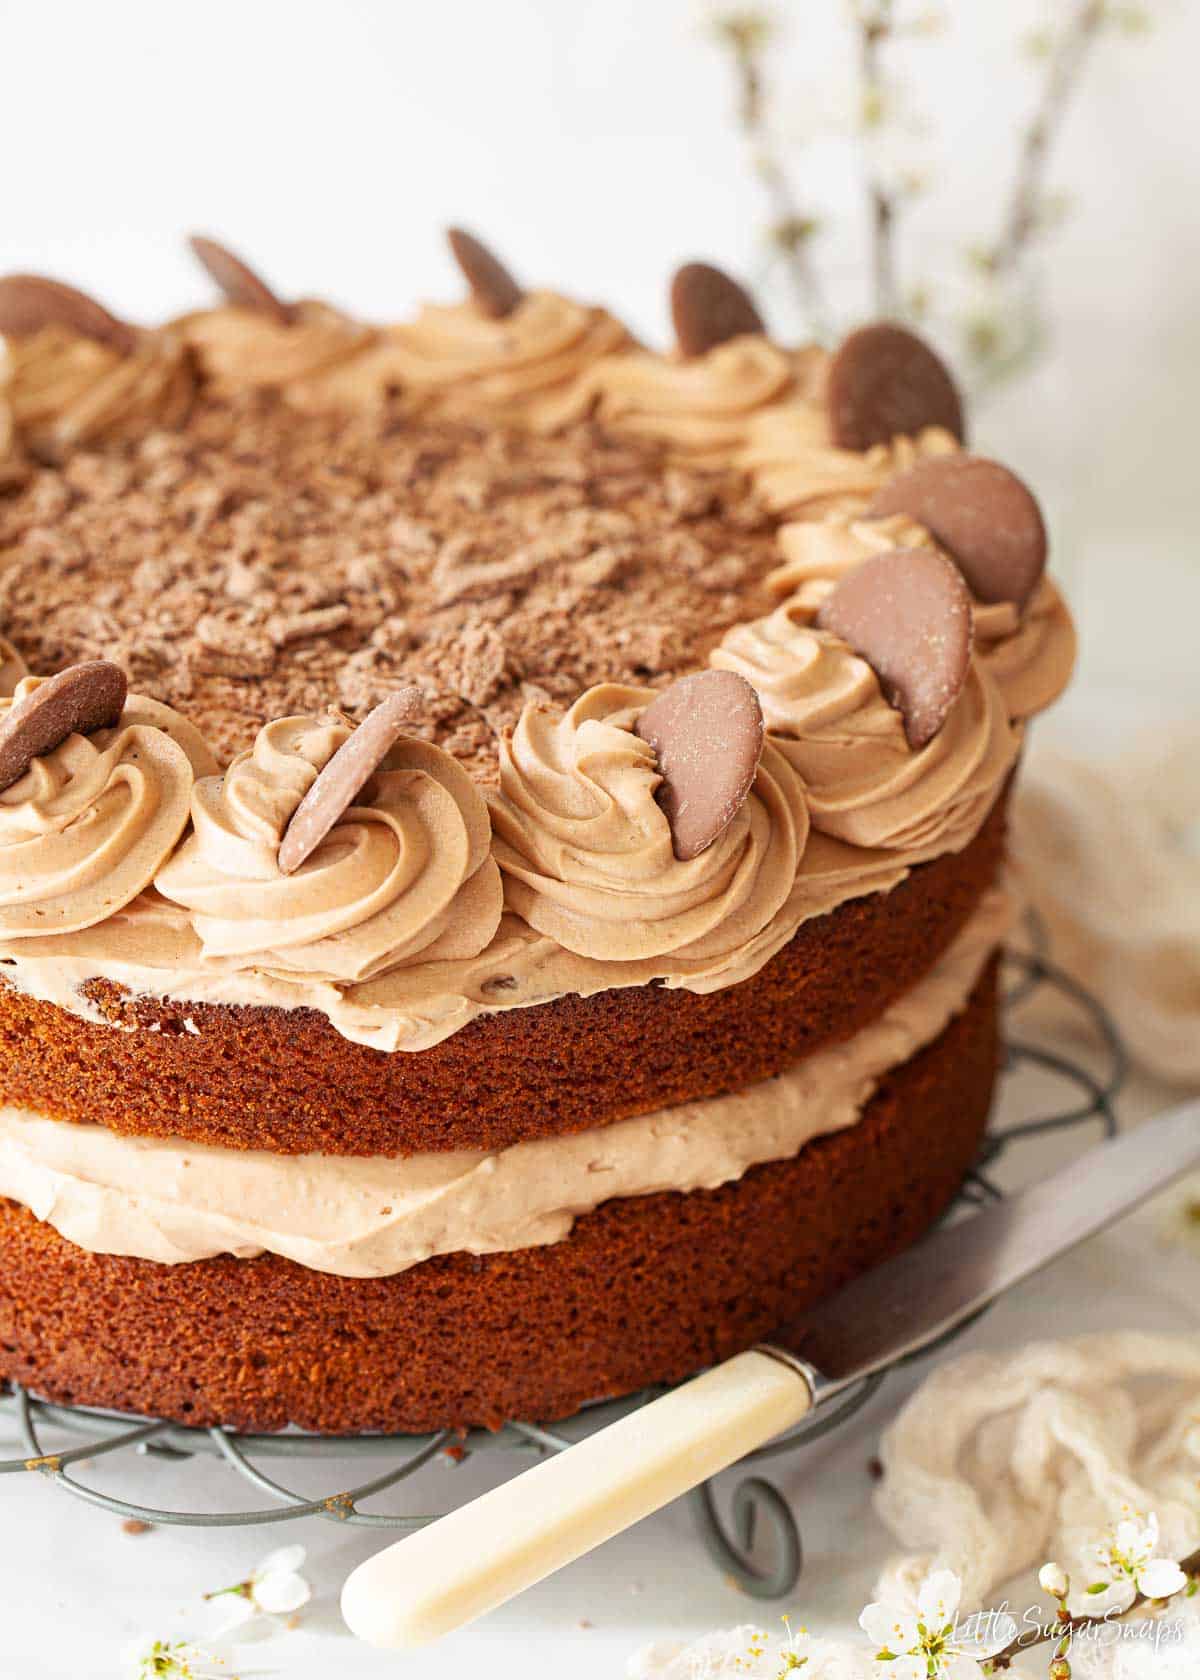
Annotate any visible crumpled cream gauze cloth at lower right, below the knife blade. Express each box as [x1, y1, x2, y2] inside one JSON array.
[[876, 1331, 1200, 1614]]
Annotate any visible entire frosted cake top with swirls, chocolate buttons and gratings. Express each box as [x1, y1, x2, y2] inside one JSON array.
[[0, 240, 1074, 1048]]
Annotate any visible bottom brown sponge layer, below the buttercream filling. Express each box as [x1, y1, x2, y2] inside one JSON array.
[[0, 961, 998, 1433]]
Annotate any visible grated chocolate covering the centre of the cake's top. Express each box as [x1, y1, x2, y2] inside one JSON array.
[[0, 393, 778, 781]]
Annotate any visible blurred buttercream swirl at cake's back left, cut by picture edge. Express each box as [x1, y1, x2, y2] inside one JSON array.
[[0, 326, 197, 460]]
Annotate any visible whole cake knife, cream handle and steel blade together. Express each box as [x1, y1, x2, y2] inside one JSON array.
[[341, 1102, 1200, 1650]]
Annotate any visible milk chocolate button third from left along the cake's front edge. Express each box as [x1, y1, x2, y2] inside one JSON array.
[[634, 670, 765, 862]]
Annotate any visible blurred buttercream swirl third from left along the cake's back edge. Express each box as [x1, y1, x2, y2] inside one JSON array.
[[387, 291, 630, 432]]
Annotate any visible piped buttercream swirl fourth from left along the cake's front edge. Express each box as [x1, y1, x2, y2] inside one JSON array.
[[709, 583, 1020, 864]]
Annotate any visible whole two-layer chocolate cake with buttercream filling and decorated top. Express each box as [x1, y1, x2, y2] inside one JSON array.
[[0, 234, 1074, 1433]]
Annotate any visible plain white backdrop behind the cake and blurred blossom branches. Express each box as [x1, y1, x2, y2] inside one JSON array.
[[0, 0, 1200, 697]]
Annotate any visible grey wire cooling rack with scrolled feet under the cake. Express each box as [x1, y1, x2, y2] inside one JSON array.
[[0, 919, 1126, 1598]]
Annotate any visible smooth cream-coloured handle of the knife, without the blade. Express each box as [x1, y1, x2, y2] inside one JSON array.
[[341, 1349, 813, 1650]]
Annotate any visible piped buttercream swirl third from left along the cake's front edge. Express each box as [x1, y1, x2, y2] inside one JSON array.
[[489, 684, 808, 966]]
